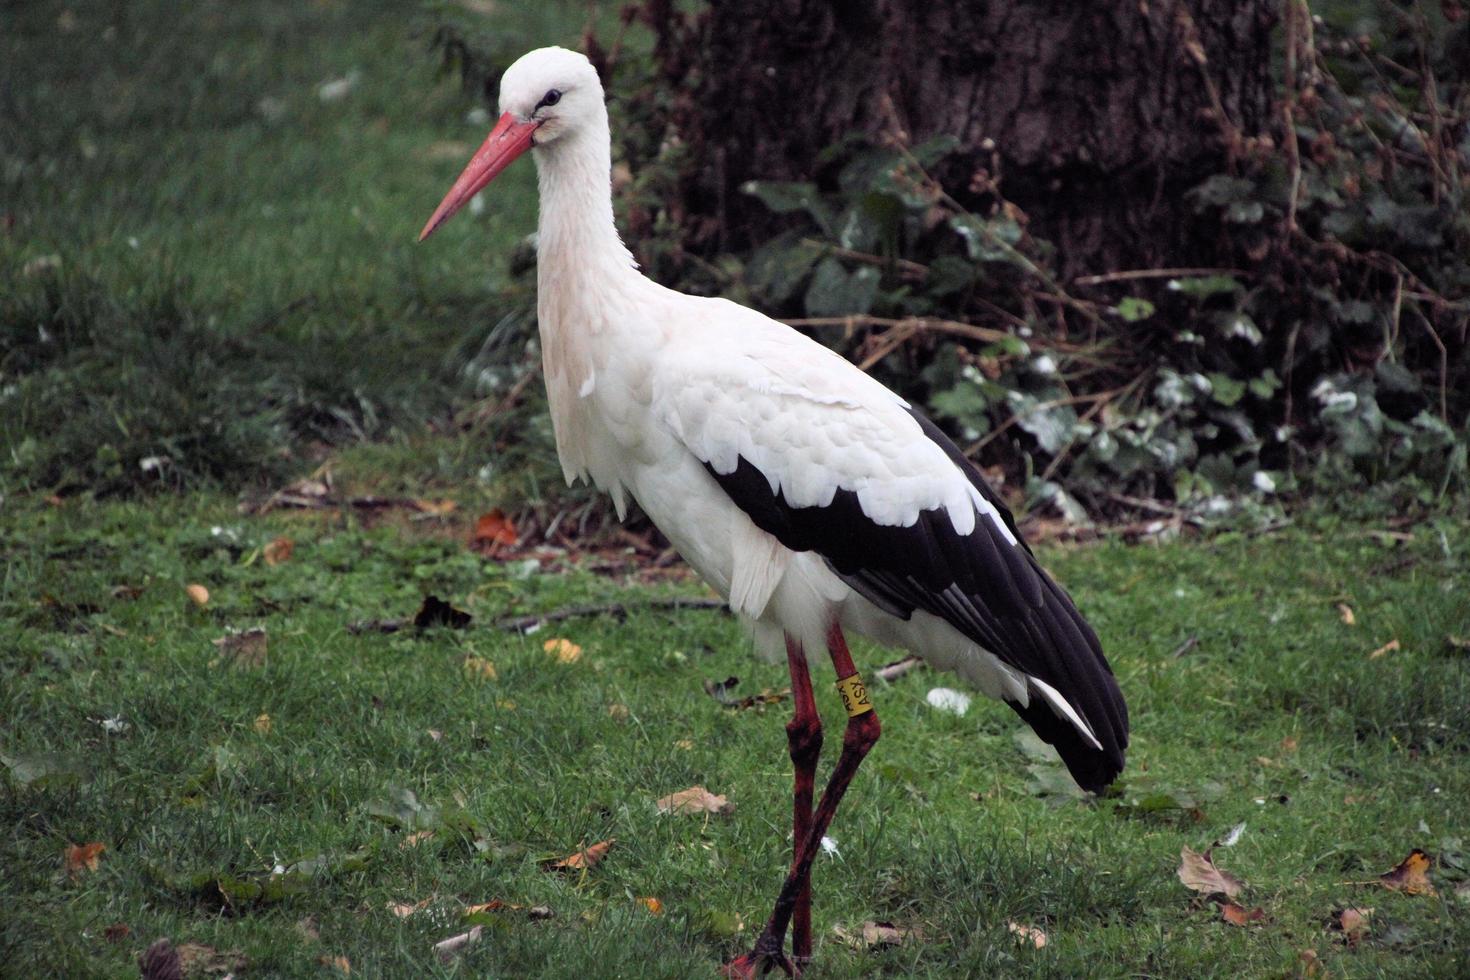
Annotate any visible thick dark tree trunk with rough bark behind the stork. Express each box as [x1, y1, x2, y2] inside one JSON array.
[[644, 0, 1274, 276]]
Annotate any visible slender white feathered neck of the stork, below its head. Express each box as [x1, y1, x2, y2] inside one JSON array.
[[535, 113, 641, 292]]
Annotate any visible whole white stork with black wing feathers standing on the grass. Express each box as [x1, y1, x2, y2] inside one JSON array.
[[419, 47, 1127, 976]]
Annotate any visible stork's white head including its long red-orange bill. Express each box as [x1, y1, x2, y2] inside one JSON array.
[[419, 47, 604, 241]]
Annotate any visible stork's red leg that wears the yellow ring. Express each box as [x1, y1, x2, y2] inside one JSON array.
[[725, 623, 882, 977]]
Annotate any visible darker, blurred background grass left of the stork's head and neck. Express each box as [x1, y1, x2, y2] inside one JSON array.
[[0, 0, 587, 492]]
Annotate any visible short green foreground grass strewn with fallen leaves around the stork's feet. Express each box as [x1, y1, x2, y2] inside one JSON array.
[[0, 497, 1470, 977]]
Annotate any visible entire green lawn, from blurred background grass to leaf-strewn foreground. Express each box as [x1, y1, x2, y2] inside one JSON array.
[[0, 0, 1470, 977]]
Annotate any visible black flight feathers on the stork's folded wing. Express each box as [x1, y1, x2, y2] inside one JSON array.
[[707, 410, 1127, 792]]
